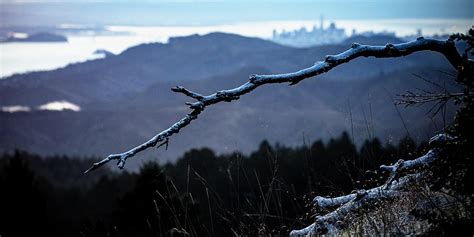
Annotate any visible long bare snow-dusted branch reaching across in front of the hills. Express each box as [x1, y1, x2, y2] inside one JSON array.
[[85, 37, 464, 173]]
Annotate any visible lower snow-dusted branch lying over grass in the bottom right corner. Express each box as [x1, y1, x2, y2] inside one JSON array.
[[290, 134, 455, 237]]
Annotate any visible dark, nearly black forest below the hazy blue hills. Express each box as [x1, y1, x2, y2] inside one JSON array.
[[0, 132, 427, 237]]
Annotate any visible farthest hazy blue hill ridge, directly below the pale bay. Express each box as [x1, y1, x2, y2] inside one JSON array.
[[0, 33, 446, 106]]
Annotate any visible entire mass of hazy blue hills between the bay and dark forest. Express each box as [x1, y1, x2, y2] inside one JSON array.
[[0, 33, 456, 168]]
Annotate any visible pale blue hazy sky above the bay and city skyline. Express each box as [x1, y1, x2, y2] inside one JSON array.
[[0, 0, 474, 25]]
